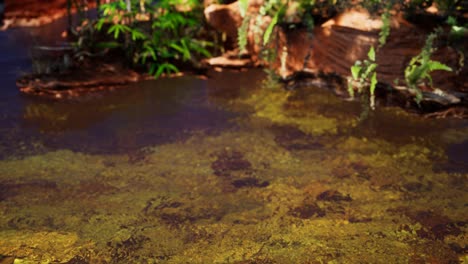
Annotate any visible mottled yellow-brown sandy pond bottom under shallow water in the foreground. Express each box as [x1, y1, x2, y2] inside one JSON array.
[[0, 69, 468, 264]]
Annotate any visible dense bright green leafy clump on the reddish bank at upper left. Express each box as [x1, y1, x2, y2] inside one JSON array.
[[96, 0, 210, 78]]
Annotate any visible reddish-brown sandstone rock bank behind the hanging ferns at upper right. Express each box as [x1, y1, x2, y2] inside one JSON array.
[[205, 2, 468, 101]]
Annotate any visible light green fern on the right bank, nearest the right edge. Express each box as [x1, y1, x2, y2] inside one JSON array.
[[405, 29, 452, 104]]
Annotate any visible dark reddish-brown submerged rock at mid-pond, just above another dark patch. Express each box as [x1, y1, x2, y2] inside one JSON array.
[[211, 150, 252, 177]]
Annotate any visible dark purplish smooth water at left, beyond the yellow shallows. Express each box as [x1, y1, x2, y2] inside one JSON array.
[[0, 13, 270, 158]]
